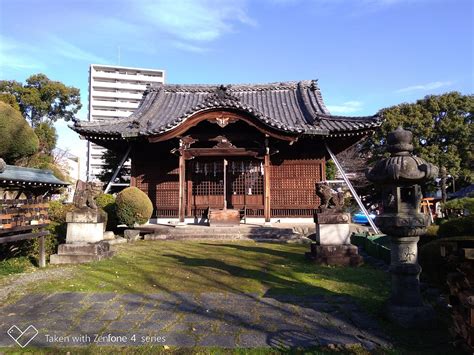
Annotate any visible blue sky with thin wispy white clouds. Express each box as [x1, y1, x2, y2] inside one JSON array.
[[0, 0, 474, 174]]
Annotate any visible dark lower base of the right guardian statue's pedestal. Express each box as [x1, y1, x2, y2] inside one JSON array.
[[306, 243, 364, 266]]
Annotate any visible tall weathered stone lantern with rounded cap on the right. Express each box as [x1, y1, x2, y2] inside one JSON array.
[[366, 127, 438, 327]]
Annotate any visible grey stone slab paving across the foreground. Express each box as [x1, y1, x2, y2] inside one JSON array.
[[0, 293, 390, 350]]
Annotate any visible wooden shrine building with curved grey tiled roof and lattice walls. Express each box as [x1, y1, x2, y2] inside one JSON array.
[[72, 80, 381, 222]]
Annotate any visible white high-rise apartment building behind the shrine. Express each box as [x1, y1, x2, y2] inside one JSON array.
[[87, 64, 165, 181]]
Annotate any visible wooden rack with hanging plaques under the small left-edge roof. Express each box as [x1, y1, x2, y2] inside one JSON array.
[[0, 198, 50, 267]]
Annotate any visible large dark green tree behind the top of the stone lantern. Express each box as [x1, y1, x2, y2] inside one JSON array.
[[365, 92, 474, 189]]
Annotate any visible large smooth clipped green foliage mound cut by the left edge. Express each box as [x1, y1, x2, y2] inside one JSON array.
[[0, 101, 39, 164]]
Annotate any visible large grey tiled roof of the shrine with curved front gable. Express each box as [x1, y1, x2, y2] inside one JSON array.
[[72, 80, 381, 137]]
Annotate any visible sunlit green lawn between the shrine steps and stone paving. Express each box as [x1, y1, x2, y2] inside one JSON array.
[[18, 241, 389, 310]]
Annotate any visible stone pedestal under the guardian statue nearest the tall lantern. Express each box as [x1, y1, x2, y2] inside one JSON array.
[[306, 211, 363, 266]]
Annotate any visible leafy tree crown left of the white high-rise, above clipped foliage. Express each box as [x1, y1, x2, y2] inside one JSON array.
[[0, 74, 82, 127]]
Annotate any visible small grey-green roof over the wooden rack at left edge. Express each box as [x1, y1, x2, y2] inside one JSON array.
[[0, 165, 69, 186]]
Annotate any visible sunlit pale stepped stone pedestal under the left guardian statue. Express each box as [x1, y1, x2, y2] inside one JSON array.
[[50, 208, 114, 264]]
